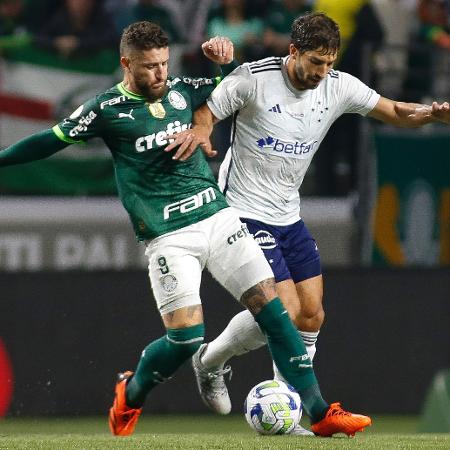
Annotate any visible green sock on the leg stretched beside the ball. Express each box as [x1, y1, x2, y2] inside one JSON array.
[[255, 298, 328, 423]]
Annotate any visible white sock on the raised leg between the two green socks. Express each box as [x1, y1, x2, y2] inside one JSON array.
[[200, 310, 267, 368]]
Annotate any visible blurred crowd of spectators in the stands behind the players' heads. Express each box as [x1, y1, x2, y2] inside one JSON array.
[[0, 0, 450, 195]]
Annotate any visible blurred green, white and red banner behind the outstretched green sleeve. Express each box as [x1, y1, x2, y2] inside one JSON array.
[[0, 45, 117, 195]]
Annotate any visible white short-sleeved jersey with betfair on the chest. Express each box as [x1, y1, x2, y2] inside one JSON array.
[[213, 57, 380, 225]]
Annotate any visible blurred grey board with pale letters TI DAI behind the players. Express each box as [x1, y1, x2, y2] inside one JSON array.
[[0, 198, 356, 272]]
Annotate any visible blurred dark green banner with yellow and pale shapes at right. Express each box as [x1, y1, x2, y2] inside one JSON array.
[[372, 132, 450, 266]]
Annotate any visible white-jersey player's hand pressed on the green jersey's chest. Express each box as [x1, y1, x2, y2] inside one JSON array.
[[164, 126, 217, 161]]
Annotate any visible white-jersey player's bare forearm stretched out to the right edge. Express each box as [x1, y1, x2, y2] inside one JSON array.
[[367, 97, 450, 128]]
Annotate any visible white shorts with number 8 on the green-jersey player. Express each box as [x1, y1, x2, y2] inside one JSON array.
[[145, 208, 273, 314]]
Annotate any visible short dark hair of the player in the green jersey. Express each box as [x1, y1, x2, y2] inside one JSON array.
[[120, 21, 169, 55]]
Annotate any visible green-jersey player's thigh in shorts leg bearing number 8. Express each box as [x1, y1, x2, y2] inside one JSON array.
[[145, 232, 204, 325]]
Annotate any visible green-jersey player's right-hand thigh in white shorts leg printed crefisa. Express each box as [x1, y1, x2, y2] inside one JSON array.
[[207, 208, 276, 301]]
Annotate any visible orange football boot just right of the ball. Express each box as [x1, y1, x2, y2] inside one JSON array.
[[311, 403, 372, 437]]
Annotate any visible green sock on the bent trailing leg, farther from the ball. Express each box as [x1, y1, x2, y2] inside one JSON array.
[[126, 324, 205, 408]]
